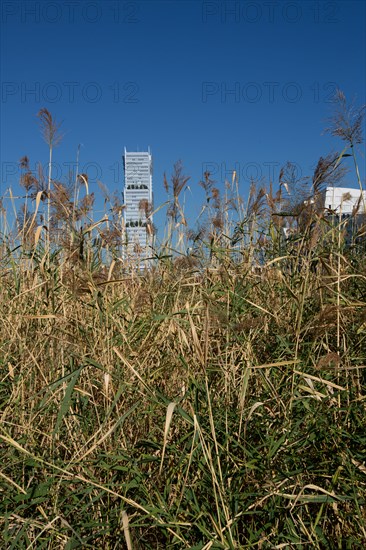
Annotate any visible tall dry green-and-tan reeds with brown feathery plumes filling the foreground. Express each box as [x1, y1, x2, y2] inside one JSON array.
[[0, 95, 366, 550]]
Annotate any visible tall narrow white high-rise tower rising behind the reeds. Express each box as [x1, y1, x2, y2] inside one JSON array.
[[123, 148, 153, 265]]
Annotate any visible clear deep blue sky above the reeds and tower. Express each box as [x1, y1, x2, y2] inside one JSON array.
[[1, 0, 366, 232]]
